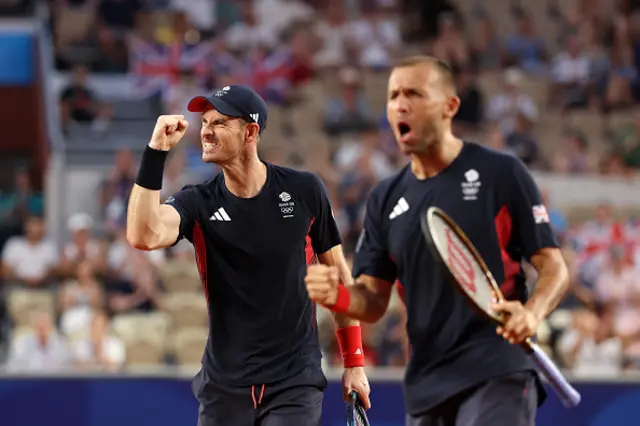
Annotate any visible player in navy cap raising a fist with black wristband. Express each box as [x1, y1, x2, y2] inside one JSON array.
[[127, 85, 369, 426]]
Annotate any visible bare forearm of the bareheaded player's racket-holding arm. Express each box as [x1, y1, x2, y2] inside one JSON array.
[[526, 258, 569, 321]]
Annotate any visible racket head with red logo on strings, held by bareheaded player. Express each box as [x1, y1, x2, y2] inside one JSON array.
[[421, 207, 505, 324]]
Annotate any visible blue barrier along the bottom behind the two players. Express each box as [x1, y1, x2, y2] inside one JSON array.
[[0, 377, 640, 426]]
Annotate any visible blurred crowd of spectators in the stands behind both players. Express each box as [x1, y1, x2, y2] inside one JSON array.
[[0, 0, 640, 375]]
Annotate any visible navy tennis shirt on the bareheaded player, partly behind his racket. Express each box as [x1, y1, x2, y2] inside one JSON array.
[[353, 142, 557, 416]]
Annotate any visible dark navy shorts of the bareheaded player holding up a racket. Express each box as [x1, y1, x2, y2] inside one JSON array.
[[407, 371, 538, 426]]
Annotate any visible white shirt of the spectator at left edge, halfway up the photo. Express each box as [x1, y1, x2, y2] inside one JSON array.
[[2, 237, 58, 279]]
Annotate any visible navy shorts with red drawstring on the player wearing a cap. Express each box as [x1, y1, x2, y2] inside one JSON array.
[[193, 367, 327, 426]]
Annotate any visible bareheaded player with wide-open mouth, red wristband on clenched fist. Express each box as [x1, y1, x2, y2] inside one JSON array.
[[306, 57, 568, 426]]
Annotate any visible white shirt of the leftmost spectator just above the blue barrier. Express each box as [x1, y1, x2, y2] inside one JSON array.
[[7, 332, 71, 372]]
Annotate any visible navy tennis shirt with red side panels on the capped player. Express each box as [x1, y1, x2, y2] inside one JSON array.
[[166, 164, 341, 387]]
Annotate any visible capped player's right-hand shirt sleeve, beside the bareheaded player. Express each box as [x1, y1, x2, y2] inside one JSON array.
[[309, 175, 342, 254]]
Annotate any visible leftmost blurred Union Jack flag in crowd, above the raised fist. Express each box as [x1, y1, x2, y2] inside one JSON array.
[[129, 37, 212, 97]]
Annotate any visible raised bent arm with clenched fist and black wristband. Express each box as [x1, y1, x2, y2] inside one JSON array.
[[127, 115, 188, 250]]
